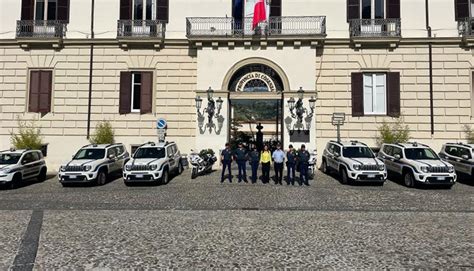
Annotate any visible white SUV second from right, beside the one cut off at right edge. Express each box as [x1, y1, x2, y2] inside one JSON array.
[[379, 142, 457, 187]]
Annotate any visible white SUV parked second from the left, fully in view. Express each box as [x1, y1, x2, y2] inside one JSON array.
[[58, 143, 130, 186]]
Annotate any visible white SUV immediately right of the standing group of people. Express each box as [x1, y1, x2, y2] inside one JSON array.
[[321, 141, 387, 184]]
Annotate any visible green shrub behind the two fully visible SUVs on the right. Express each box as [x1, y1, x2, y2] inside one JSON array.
[[377, 118, 410, 147]]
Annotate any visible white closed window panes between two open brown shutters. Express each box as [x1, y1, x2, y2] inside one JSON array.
[[364, 73, 387, 115]]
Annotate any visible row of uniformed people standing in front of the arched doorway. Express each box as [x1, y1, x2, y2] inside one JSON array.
[[221, 143, 311, 185]]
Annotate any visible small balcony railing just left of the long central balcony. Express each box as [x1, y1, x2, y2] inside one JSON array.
[[117, 20, 166, 39]]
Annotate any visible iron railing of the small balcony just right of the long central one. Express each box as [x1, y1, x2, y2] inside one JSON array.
[[349, 19, 401, 38]]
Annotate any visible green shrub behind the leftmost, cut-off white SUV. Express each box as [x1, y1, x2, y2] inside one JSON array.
[[10, 118, 43, 150]]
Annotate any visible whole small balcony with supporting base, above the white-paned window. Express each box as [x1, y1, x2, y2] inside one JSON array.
[[349, 19, 402, 47]]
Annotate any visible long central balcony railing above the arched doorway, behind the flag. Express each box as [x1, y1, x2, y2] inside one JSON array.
[[186, 16, 326, 39]]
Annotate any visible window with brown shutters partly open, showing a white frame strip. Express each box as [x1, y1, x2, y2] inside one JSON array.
[[119, 72, 153, 114]]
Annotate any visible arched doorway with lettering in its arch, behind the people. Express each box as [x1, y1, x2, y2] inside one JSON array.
[[224, 60, 288, 152]]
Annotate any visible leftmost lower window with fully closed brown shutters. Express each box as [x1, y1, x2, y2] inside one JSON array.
[[28, 70, 53, 113]]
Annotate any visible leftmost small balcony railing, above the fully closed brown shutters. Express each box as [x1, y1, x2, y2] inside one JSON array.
[[16, 20, 67, 39]]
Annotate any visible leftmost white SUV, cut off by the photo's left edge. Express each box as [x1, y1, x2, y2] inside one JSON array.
[[0, 149, 48, 188]]
